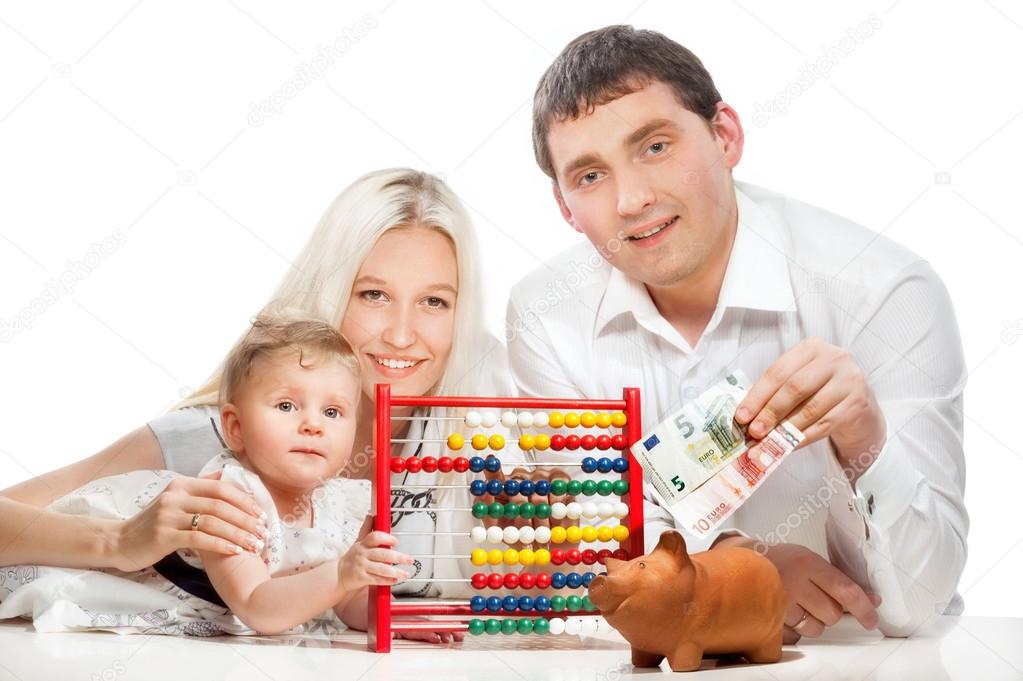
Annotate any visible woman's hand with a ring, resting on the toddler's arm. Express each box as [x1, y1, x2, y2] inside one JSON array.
[[110, 471, 267, 572]]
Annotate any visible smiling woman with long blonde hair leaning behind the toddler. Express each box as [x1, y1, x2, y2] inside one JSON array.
[[0, 169, 513, 640]]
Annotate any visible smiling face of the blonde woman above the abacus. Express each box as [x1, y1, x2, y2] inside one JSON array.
[[341, 227, 458, 399]]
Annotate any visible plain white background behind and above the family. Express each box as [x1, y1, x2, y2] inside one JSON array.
[[0, 0, 1023, 617]]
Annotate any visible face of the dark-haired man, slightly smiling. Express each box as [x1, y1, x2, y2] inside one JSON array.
[[547, 81, 743, 286]]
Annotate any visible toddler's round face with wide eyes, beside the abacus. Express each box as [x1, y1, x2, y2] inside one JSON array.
[[221, 353, 360, 492]]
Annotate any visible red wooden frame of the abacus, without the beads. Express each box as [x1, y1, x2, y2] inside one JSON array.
[[366, 383, 643, 652]]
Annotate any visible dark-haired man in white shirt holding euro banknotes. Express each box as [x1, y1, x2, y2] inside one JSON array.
[[508, 27, 969, 642]]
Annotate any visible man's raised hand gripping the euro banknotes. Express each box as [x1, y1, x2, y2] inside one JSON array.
[[736, 338, 887, 476]]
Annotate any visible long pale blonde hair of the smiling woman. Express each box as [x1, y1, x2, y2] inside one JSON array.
[[173, 168, 491, 409]]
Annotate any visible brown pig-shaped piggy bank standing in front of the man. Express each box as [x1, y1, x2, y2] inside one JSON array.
[[589, 531, 785, 672]]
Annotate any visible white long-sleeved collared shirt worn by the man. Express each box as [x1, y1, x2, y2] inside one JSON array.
[[506, 182, 969, 635]]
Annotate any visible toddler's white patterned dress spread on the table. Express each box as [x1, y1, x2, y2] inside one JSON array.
[[0, 452, 370, 636]]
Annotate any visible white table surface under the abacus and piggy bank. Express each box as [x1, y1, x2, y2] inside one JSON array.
[[0, 617, 1023, 681]]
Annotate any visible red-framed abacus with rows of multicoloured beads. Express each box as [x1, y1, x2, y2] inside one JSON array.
[[367, 383, 643, 652]]
